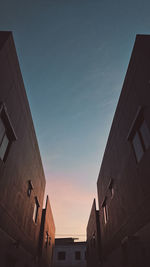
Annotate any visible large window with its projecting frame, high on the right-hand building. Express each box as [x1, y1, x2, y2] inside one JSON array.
[[128, 107, 150, 162]]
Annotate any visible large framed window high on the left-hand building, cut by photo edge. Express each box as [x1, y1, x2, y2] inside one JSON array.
[[0, 103, 17, 162]]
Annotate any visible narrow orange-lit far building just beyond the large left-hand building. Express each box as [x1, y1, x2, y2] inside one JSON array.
[[39, 196, 55, 267]]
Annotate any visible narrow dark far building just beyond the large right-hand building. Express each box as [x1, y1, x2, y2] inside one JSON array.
[[86, 199, 101, 267]]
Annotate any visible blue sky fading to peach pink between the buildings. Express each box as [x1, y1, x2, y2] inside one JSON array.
[[0, 0, 150, 240]]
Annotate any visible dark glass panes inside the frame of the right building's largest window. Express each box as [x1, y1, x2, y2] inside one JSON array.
[[131, 120, 150, 162]]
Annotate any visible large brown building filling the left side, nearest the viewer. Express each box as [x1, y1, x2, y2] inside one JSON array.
[[0, 32, 55, 267]]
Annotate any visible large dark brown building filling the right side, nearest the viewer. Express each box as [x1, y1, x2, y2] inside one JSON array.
[[97, 35, 150, 267]]
